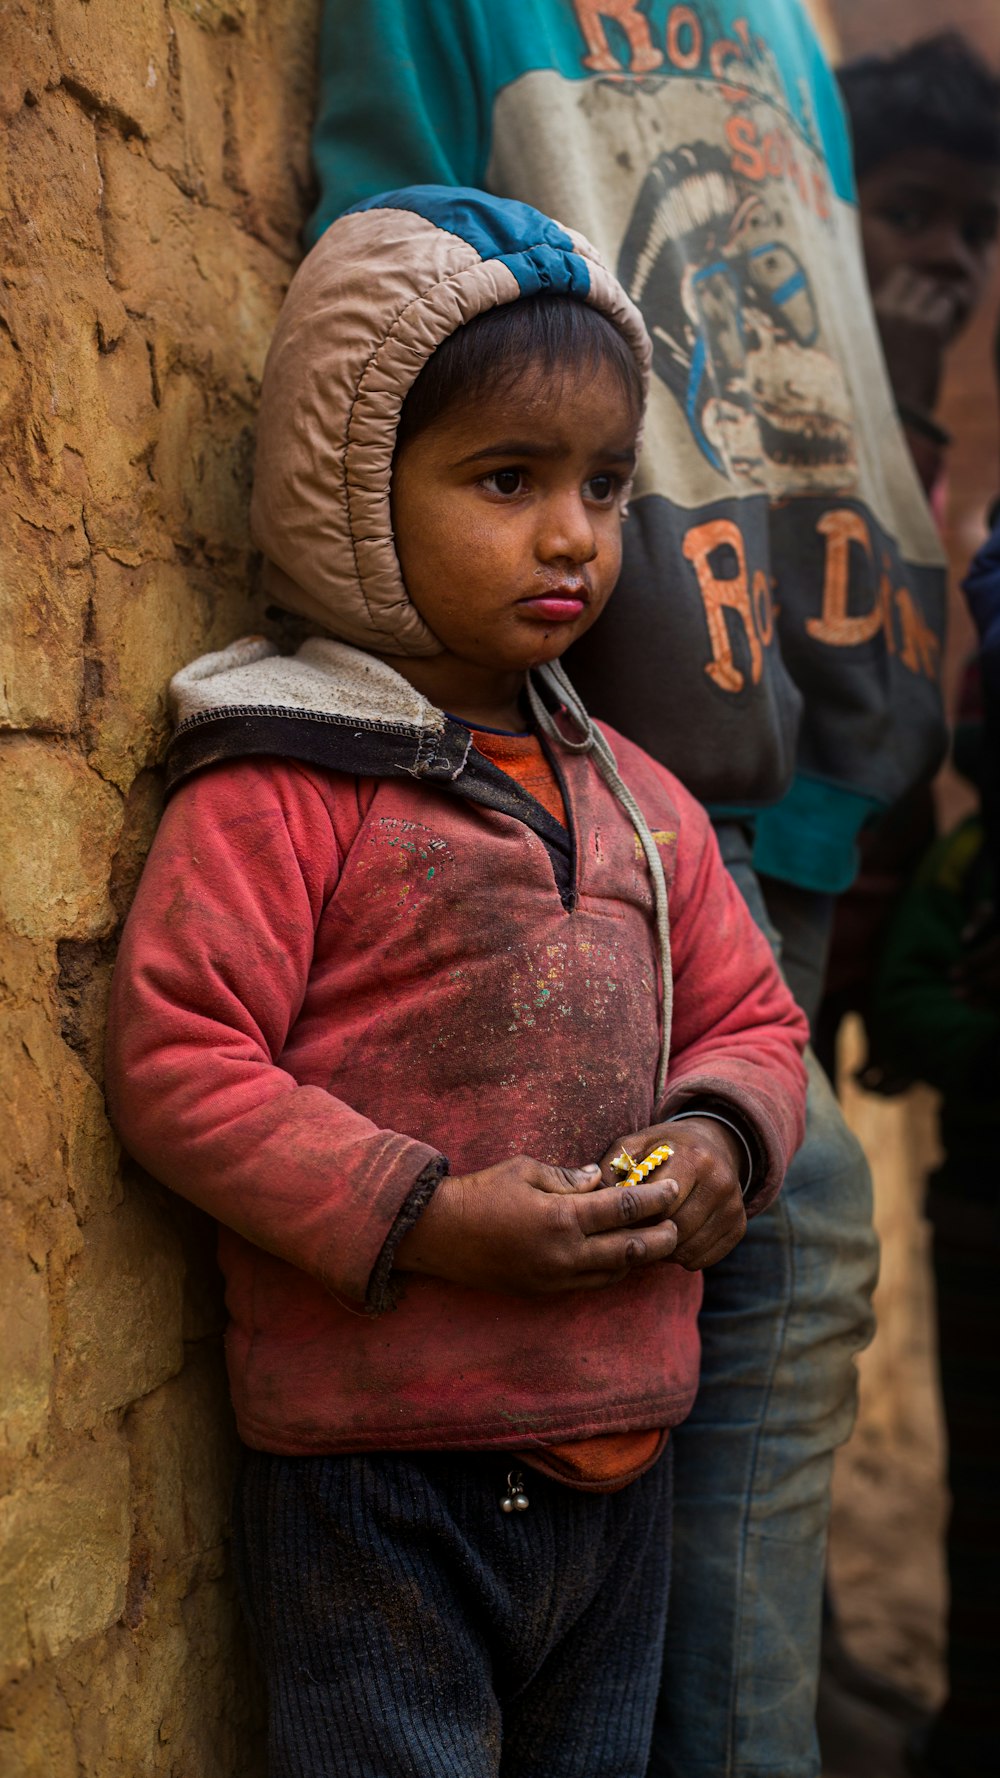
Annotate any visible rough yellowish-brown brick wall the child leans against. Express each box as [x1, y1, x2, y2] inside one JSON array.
[[0, 0, 317, 1778]]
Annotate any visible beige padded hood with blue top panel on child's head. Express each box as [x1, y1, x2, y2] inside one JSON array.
[[251, 185, 649, 654]]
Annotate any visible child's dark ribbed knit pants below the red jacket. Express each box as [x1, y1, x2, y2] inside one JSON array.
[[235, 1447, 671, 1778]]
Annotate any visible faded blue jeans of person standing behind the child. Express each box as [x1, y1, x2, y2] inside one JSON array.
[[649, 825, 877, 1778]]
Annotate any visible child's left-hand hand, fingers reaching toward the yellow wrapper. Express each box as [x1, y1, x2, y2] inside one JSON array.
[[395, 1156, 678, 1296]]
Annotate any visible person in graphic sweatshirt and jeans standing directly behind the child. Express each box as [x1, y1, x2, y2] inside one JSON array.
[[308, 0, 945, 1778]]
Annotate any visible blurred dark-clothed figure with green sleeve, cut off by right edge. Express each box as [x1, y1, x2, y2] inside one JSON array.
[[872, 663, 1000, 1778]]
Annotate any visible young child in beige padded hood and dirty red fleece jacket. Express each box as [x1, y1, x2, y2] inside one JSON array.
[[109, 187, 806, 1778]]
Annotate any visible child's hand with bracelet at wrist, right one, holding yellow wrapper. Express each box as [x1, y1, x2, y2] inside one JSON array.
[[601, 1117, 747, 1271]]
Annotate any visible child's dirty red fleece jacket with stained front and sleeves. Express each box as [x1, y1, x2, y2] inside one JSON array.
[[109, 733, 806, 1453]]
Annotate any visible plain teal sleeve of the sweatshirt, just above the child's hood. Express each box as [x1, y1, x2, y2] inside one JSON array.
[[306, 0, 493, 247]]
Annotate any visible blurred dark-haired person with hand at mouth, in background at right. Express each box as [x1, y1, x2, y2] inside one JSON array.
[[813, 45, 1000, 1092]]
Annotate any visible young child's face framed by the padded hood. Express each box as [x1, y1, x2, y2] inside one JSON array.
[[391, 364, 637, 715]]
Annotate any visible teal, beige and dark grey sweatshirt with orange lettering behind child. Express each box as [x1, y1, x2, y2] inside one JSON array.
[[313, 0, 945, 889]]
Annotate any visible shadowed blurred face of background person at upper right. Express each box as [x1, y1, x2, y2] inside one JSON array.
[[858, 148, 1000, 345]]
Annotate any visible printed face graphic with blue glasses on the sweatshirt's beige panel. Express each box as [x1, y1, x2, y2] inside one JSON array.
[[617, 142, 856, 496]]
